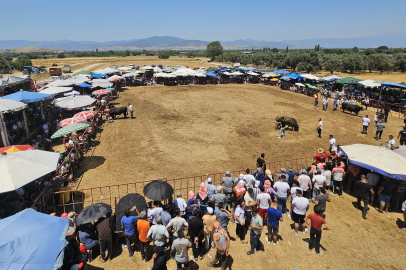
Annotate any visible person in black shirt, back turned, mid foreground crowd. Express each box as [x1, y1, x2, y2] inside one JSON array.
[[189, 209, 204, 261]]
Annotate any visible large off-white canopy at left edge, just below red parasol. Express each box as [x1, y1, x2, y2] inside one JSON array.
[[0, 150, 60, 193]]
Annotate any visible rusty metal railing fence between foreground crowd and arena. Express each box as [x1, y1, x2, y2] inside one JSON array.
[[37, 157, 313, 214]]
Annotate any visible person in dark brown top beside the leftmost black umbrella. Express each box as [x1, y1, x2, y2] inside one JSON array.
[[96, 212, 114, 263]]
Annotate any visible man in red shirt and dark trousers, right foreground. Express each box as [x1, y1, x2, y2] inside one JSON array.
[[305, 205, 330, 255]]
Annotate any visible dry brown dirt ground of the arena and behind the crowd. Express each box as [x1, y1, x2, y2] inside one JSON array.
[[72, 85, 406, 269]]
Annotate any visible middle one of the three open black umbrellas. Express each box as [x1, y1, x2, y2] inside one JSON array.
[[116, 193, 147, 231]]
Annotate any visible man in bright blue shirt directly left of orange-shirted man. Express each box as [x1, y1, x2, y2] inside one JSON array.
[[121, 206, 140, 257]]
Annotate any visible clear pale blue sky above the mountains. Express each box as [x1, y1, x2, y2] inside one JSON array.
[[0, 0, 406, 41]]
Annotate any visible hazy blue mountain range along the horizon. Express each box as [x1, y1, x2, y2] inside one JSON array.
[[0, 34, 406, 51]]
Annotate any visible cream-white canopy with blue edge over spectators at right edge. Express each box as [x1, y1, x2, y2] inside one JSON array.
[[340, 144, 406, 180]]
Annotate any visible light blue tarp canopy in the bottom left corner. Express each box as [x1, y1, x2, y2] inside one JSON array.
[[0, 209, 69, 270]]
